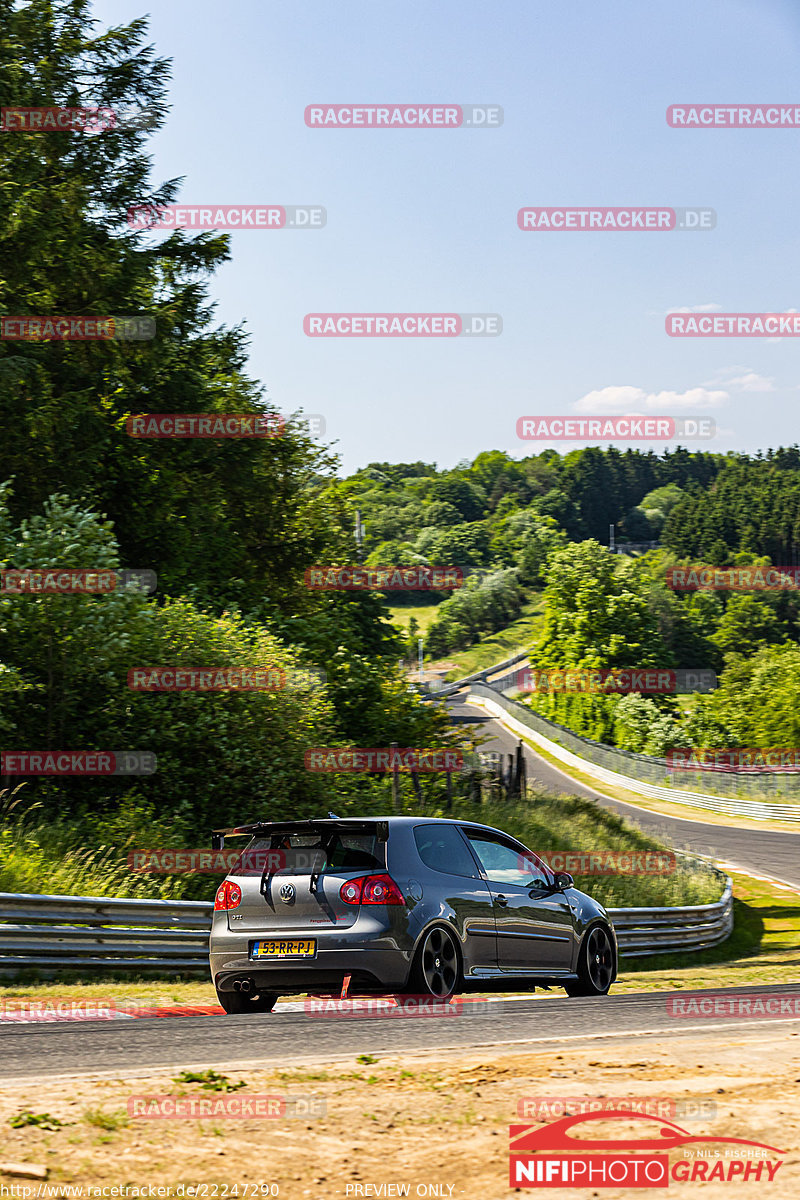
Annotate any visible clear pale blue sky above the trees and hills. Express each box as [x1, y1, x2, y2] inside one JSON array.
[[94, 0, 800, 472]]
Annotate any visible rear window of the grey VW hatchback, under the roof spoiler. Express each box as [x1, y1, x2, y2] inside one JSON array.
[[237, 830, 386, 875]]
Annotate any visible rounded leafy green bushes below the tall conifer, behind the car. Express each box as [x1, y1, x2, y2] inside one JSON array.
[[0, 490, 446, 838]]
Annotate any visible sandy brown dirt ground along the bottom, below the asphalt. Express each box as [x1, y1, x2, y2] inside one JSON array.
[[0, 1022, 800, 1200]]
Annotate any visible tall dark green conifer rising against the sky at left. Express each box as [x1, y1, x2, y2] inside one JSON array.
[[0, 0, 349, 610]]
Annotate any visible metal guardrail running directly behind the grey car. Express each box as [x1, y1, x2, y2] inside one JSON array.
[[0, 876, 733, 976]]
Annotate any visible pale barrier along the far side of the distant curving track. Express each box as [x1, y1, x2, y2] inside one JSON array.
[[471, 680, 800, 821]]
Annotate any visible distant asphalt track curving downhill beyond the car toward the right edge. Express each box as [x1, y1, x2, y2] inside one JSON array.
[[449, 694, 800, 888]]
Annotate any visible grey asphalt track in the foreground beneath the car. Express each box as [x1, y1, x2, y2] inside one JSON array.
[[0, 985, 800, 1080]]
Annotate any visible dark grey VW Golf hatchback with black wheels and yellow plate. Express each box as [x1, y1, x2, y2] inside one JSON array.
[[210, 816, 616, 1013]]
